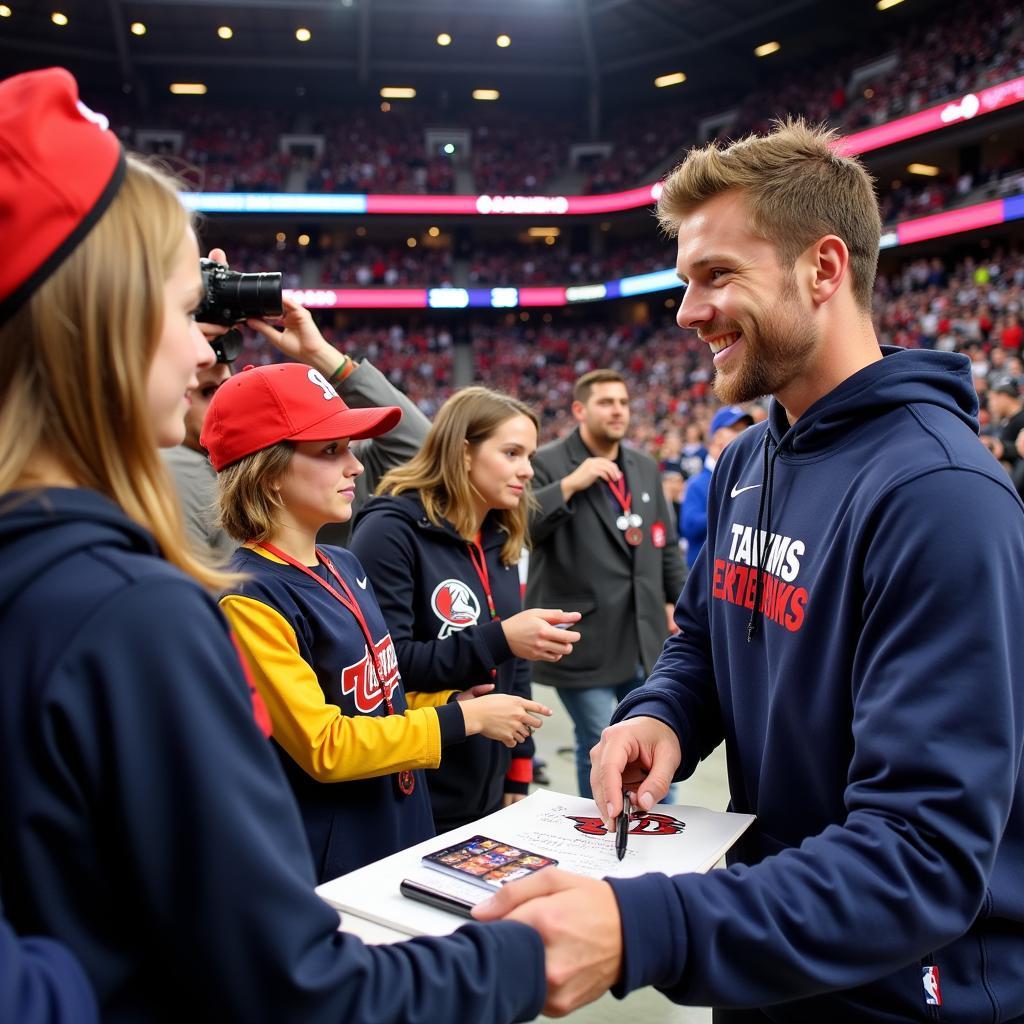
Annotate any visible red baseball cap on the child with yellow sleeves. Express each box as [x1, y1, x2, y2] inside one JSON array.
[[200, 362, 401, 473]]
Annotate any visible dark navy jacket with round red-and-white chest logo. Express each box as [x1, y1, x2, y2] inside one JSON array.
[[350, 495, 534, 831]]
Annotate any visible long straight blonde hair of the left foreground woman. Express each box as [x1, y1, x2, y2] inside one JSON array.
[[0, 157, 232, 589]]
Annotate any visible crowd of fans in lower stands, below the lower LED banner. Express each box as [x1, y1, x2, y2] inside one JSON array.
[[222, 242, 1024, 499]]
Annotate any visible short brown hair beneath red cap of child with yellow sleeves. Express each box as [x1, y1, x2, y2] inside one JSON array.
[[217, 441, 295, 544]]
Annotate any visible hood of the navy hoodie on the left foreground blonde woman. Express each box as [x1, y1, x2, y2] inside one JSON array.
[[0, 487, 160, 612]]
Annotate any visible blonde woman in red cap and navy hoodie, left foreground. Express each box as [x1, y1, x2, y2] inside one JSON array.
[[0, 69, 545, 1024]]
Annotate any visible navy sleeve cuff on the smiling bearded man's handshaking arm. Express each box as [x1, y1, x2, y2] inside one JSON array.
[[604, 874, 687, 999]]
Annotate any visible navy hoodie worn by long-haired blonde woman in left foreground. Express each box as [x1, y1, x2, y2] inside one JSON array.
[[0, 489, 545, 1024]]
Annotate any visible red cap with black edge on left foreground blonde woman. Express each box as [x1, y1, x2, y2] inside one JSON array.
[[0, 68, 125, 323]]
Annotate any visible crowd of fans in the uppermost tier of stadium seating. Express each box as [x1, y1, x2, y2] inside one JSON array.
[[112, 0, 1024, 197]]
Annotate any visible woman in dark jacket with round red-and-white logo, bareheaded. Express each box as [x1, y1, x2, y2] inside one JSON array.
[[351, 387, 580, 831]]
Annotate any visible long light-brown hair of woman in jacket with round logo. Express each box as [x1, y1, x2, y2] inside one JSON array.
[[377, 387, 541, 565]]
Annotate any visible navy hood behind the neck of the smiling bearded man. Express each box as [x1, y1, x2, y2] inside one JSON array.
[[768, 345, 978, 458]]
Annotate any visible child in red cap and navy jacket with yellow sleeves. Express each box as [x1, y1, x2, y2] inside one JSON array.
[[202, 364, 550, 882]]
